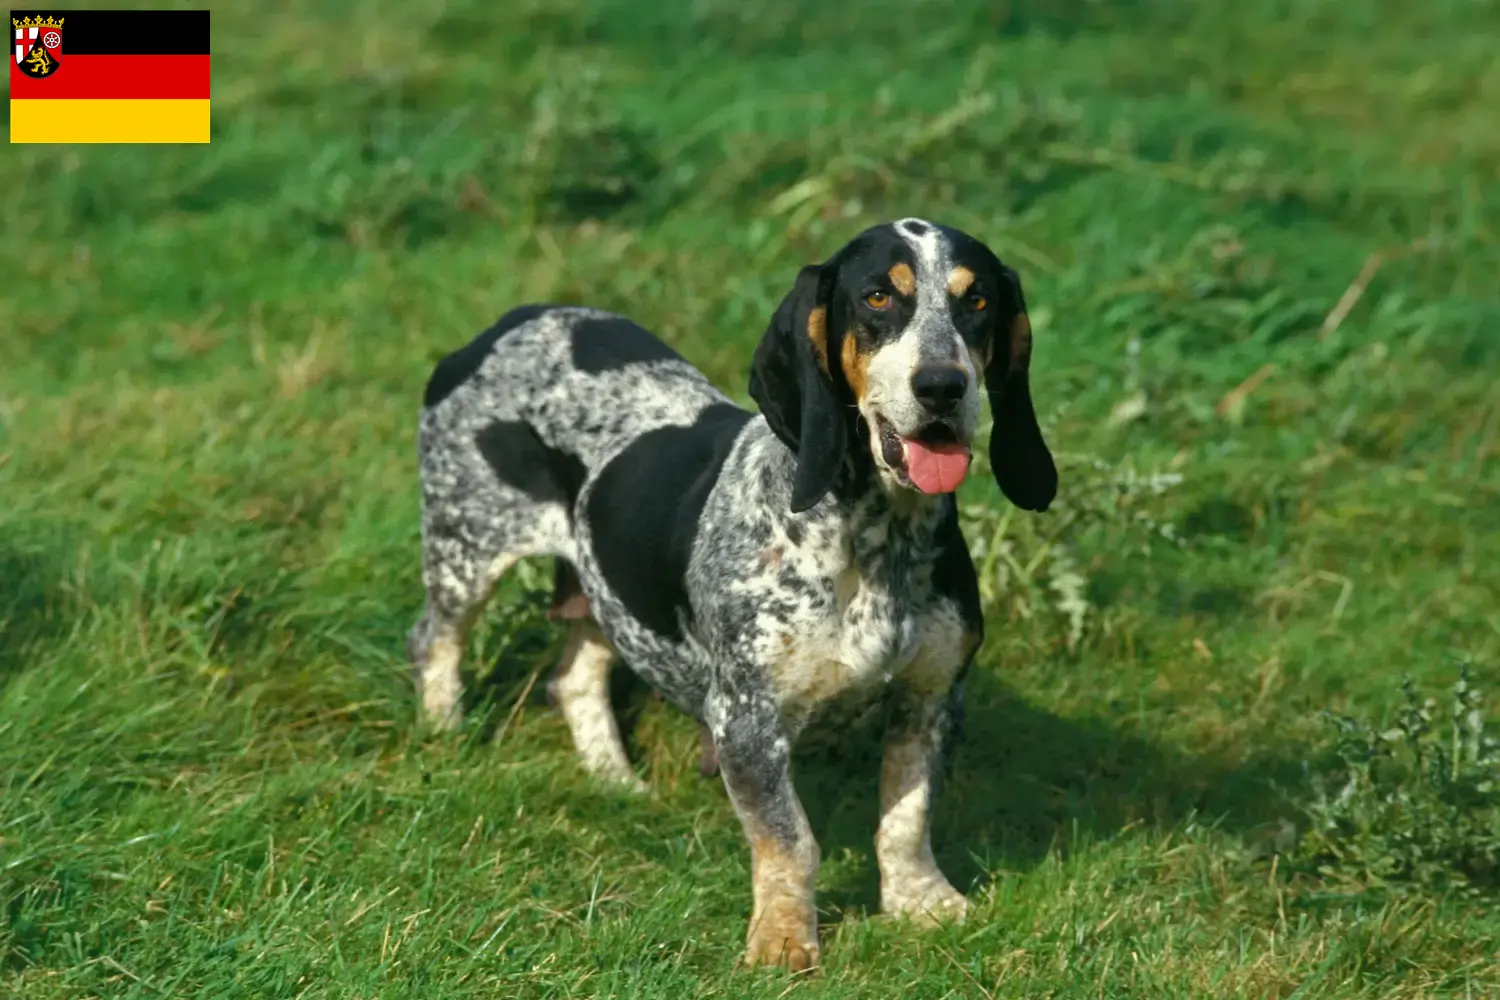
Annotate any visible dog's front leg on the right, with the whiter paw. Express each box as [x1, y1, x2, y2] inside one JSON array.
[[875, 691, 969, 922]]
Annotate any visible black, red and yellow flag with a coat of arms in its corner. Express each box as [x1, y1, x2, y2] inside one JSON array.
[[11, 10, 210, 142]]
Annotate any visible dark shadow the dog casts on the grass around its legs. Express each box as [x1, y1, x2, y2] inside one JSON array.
[[456, 594, 1301, 919]]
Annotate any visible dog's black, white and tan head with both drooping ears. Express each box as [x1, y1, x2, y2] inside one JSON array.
[[750, 219, 1058, 511]]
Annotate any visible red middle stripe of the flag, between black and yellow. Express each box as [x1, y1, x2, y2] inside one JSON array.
[[9, 54, 209, 100]]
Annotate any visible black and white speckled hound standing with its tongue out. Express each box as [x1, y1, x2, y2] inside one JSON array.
[[408, 219, 1058, 969]]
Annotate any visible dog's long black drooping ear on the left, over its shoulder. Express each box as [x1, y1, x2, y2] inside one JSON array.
[[750, 265, 848, 514]]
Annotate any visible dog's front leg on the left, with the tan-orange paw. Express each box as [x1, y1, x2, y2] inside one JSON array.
[[707, 693, 819, 972]]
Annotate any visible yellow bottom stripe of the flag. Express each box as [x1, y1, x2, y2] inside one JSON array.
[[11, 100, 209, 142]]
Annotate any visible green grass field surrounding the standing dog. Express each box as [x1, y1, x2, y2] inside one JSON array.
[[0, 0, 1500, 1000]]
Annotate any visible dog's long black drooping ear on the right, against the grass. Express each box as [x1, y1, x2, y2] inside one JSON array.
[[984, 268, 1058, 511]]
